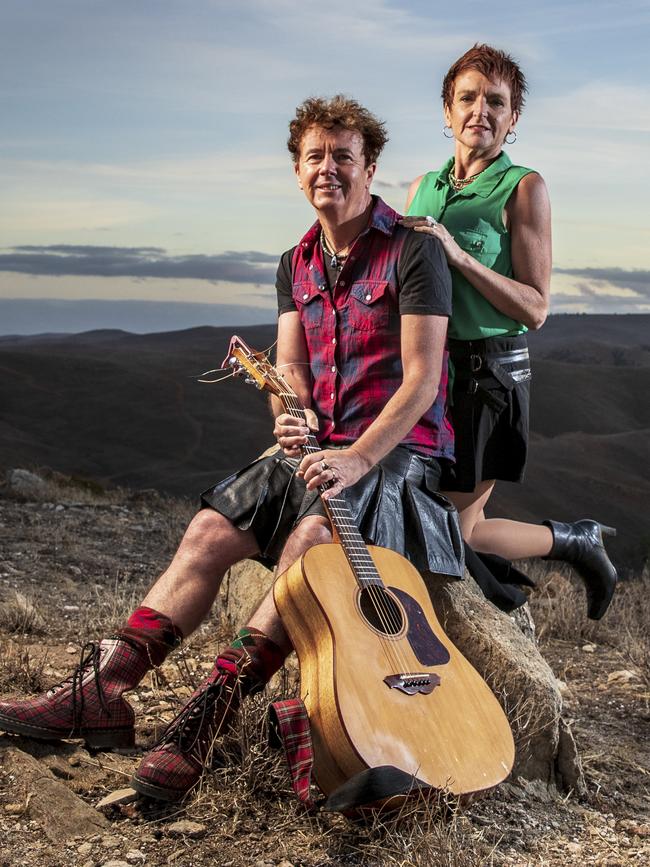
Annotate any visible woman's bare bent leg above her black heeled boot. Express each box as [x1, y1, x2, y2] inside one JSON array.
[[445, 481, 553, 560]]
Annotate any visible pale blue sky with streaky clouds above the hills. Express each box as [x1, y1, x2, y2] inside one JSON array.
[[0, 0, 650, 334]]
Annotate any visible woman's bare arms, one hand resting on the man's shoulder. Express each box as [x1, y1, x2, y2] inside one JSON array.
[[404, 173, 551, 329]]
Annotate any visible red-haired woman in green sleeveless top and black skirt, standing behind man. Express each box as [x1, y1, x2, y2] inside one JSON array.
[[404, 45, 616, 619]]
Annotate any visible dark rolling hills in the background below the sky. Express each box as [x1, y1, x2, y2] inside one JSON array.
[[0, 315, 650, 570]]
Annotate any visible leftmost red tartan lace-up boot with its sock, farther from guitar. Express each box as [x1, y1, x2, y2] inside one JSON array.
[[0, 607, 181, 749]]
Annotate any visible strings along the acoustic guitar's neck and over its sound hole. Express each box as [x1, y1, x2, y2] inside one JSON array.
[[276, 380, 408, 672]]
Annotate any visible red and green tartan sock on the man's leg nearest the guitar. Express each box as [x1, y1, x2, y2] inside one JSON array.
[[216, 626, 287, 695]]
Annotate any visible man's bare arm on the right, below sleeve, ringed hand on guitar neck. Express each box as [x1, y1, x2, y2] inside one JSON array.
[[300, 314, 447, 497]]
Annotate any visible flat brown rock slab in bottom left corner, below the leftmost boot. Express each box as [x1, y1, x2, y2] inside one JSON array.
[[3, 747, 108, 842]]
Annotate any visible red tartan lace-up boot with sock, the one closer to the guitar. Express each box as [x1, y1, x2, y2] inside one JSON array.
[[131, 629, 286, 801]]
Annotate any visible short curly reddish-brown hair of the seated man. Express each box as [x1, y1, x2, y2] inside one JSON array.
[[287, 93, 388, 166]]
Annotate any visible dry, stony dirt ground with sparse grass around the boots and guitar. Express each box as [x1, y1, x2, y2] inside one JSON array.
[[0, 484, 650, 867]]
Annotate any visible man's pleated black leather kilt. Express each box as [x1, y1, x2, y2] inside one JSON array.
[[201, 446, 464, 578]]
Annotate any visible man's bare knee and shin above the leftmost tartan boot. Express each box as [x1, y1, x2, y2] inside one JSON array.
[[142, 509, 259, 638]]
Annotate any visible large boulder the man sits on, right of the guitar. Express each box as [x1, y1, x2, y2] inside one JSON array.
[[427, 573, 585, 791]]
